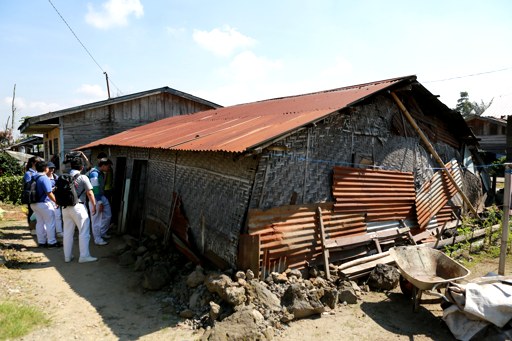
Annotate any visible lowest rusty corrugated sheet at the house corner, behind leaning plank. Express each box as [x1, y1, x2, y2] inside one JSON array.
[[248, 203, 366, 272]]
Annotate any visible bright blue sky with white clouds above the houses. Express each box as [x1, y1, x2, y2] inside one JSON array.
[[0, 0, 512, 137]]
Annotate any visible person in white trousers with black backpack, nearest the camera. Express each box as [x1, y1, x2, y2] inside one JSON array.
[[62, 158, 98, 263]]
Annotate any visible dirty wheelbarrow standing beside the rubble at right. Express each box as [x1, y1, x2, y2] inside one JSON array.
[[389, 245, 471, 311]]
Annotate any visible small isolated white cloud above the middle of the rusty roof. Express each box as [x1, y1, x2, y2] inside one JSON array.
[[192, 26, 256, 57]]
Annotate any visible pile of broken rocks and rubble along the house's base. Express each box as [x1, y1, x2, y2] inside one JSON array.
[[118, 237, 398, 340]]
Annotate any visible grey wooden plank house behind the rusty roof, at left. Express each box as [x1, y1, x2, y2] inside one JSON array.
[[19, 87, 220, 169]]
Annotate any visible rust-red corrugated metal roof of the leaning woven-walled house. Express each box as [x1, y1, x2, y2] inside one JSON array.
[[78, 76, 416, 152]]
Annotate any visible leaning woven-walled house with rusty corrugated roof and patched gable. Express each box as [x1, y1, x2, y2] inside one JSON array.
[[79, 76, 488, 273]]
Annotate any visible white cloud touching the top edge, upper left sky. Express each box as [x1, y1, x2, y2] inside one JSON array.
[[85, 0, 144, 29]]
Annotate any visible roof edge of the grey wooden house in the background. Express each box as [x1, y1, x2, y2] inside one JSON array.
[[18, 86, 223, 133]]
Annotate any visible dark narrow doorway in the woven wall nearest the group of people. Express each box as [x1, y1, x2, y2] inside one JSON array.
[[126, 160, 148, 238]]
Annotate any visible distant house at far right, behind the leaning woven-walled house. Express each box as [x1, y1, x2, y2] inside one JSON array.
[[466, 115, 507, 163]]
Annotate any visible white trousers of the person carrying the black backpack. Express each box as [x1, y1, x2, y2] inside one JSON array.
[[62, 204, 91, 259]]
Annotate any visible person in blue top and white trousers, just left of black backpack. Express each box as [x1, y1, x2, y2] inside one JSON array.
[[30, 161, 60, 248]]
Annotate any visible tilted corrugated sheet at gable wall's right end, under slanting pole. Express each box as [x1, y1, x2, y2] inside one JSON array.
[[416, 160, 462, 229]]
